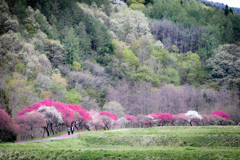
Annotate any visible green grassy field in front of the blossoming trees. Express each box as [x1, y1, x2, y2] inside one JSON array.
[[0, 126, 240, 160]]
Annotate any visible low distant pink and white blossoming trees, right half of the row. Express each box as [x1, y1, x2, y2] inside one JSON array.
[[118, 111, 234, 127]]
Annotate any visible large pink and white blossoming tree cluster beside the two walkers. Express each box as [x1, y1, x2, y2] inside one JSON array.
[[16, 100, 118, 139]]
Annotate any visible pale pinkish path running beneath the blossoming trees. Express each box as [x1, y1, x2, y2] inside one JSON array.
[[17, 129, 129, 143]]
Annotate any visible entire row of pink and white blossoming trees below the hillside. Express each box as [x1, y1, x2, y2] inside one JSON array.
[[0, 100, 233, 141]]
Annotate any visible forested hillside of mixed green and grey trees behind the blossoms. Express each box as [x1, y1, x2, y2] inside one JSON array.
[[0, 0, 240, 123]]
